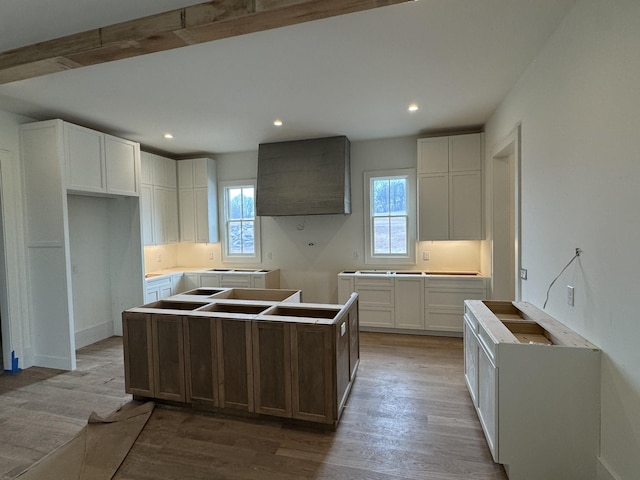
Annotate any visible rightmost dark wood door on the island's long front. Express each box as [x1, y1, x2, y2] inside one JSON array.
[[291, 323, 337, 424]]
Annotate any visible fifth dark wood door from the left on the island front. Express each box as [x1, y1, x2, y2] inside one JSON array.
[[252, 320, 296, 417]]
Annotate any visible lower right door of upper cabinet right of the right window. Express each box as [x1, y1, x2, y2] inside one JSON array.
[[449, 171, 482, 240]]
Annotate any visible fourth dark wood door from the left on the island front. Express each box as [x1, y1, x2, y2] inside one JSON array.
[[217, 318, 254, 412]]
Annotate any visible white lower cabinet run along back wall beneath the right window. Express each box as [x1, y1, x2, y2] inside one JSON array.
[[338, 271, 486, 336]]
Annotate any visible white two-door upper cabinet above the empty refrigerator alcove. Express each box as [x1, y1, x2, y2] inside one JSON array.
[[63, 122, 140, 197]]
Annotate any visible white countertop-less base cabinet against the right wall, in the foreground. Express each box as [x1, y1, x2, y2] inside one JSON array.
[[464, 300, 600, 480]]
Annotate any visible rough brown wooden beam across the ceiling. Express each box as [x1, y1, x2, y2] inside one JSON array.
[[0, 0, 410, 84]]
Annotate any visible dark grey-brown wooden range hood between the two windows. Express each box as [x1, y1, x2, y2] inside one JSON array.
[[256, 136, 351, 217]]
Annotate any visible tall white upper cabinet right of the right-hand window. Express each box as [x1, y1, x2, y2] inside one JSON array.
[[417, 133, 483, 241]]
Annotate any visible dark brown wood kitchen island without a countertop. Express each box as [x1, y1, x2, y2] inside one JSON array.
[[122, 288, 360, 428]]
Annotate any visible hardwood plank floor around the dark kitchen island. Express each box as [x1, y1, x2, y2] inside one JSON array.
[[0, 333, 507, 480]]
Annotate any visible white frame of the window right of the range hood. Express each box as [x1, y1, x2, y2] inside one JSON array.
[[363, 168, 418, 265]]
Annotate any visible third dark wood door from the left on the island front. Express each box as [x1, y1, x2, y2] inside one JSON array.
[[184, 316, 219, 407]]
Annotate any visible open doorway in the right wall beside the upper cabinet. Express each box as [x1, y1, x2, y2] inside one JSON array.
[[491, 125, 522, 300]]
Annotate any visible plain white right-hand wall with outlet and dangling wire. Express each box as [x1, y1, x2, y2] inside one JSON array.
[[483, 0, 640, 480]]
